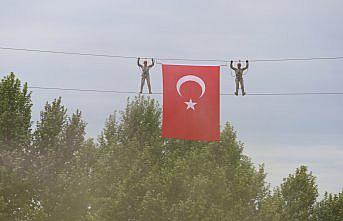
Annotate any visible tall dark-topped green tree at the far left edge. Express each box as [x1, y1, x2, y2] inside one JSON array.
[[0, 73, 40, 220]]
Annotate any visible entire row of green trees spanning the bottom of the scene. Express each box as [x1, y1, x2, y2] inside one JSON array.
[[0, 73, 343, 221]]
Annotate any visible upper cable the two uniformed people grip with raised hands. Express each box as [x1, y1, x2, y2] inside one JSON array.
[[0, 46, 343, 63]]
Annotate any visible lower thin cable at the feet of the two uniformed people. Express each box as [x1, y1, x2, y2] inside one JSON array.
[[29, 86, 343, 96]]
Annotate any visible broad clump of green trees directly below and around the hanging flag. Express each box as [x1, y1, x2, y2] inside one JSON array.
[[92, 97, 266, 220]]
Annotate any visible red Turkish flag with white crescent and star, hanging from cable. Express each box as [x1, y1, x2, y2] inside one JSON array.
[[162, 64, 220, 141]]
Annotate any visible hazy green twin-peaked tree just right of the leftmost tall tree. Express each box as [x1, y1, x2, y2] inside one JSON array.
[[33, 97, 93, 220]]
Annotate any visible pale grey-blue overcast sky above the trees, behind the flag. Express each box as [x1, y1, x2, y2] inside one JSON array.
[[0, 0, 343, 194]]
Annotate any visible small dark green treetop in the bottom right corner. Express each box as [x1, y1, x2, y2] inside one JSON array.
[[315, 192, 343, 221]]
